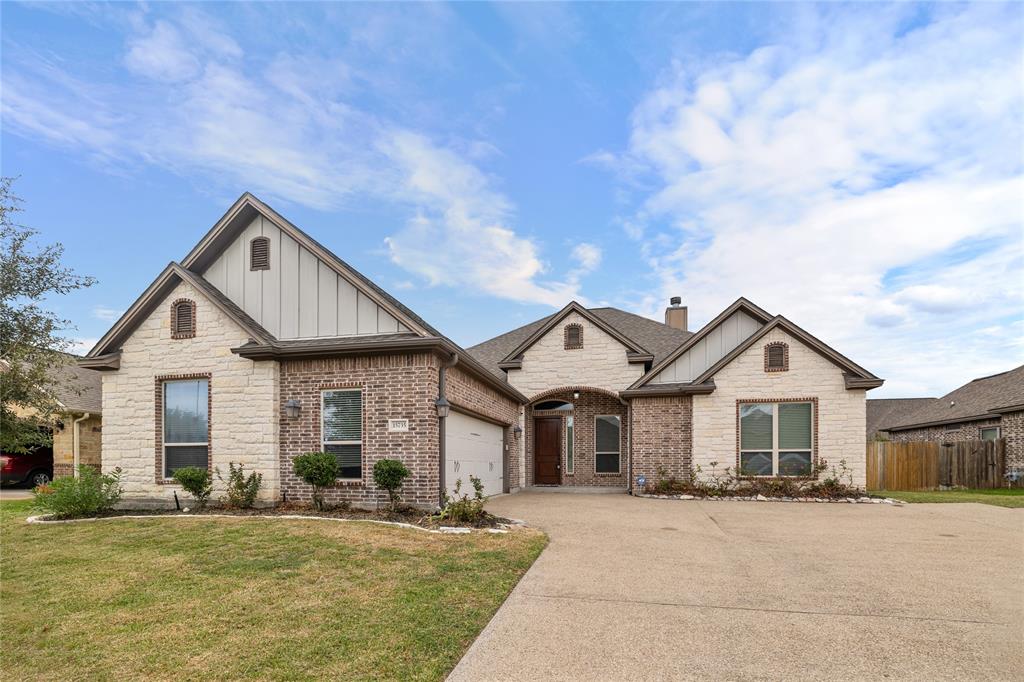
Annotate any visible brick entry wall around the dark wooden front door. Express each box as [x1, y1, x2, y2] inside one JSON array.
[[524, 390, 630, 486]]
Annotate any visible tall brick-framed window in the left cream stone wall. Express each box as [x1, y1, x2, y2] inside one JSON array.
[[163, 379, 210, 478]]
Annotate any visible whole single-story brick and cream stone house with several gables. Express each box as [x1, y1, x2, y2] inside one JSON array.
[[81, 194, 882, 507]]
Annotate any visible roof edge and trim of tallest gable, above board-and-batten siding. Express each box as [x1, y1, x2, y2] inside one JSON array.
[[181, 191, 440, 336]]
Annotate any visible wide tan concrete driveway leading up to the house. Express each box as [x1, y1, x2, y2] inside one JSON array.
[[450, 493, 1024, 680]]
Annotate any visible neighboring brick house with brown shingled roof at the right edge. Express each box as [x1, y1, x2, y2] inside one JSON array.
[[881, 365, 1024, 468]]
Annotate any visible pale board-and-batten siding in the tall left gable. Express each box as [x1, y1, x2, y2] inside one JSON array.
[[203, 216, 410, 339]]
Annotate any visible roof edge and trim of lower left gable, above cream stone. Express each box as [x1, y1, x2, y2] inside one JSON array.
[[79, 262, 273, 358]]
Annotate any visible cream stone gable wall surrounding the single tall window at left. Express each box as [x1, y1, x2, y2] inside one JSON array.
[[102, 283, 279, 504]]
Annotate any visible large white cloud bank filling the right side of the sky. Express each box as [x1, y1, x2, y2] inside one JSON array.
[[622, 5, 1024, 395]]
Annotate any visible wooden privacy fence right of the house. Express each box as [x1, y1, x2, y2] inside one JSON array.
[[867, 438, 1007, 491]]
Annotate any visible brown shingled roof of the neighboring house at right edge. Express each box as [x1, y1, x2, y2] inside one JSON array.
[[883, 365, 1024, 431]]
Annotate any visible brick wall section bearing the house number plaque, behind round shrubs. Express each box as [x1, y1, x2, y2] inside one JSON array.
[[281, 353, 439, 507]]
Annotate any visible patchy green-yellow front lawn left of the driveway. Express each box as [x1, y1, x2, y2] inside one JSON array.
[[0, 501, 547, 680]]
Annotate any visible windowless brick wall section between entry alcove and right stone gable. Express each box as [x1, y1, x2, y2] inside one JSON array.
[[630, 395, 693, 483]]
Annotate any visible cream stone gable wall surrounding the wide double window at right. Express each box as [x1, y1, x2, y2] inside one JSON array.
[[693, 329, 866, 487]]
